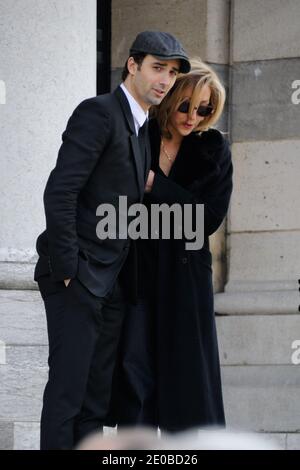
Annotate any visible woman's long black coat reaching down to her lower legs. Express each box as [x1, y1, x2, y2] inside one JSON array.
[[108, 121, 232, 431]]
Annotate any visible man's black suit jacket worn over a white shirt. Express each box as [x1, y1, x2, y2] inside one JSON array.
[[34, 87, 151, 300]]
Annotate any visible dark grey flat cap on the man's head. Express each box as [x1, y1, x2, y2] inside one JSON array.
[[129, 31, 191, 73]]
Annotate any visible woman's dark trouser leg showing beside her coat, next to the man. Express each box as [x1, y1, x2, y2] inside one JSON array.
[[111, 298, 158, 428]]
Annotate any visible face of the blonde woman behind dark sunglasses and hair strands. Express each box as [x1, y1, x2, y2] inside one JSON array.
[[168, 84, 211, 138]]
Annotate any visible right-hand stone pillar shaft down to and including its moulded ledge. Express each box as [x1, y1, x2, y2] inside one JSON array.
[[217, 0, 300, 314]]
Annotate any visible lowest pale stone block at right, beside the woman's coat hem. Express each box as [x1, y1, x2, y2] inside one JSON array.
[[222, 365, 300, 432]]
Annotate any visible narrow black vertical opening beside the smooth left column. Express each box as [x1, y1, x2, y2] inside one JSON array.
[[97, 0, 111, 95]]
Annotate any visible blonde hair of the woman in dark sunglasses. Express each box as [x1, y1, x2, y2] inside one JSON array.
[[153, 58, 226, 139]]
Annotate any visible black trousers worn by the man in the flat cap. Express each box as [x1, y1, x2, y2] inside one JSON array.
[[38, 276, 124, 450]]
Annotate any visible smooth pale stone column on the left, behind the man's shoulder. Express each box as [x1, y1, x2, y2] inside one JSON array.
[[0, 0, 96, 289]]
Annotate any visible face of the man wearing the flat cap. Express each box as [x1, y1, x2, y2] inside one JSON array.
[[128, 55, 180, 110]]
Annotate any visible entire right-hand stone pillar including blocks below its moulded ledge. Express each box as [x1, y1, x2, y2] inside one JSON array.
[[215, 0, 300, 449]]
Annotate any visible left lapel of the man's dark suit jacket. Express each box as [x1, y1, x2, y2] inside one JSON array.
[[114, 87, 145, 200]]
